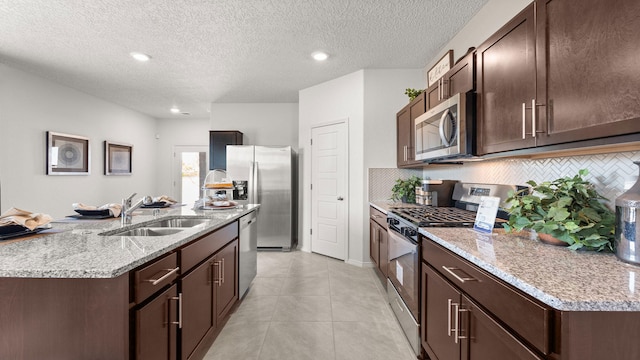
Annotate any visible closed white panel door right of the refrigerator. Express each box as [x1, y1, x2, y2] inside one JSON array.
[[311, 122, 349, 260]]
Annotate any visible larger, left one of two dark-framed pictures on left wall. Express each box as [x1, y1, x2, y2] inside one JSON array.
[[46, 131, 91, 175]]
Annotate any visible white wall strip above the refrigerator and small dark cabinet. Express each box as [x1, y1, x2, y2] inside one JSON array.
[[210, 103, 298, 151]]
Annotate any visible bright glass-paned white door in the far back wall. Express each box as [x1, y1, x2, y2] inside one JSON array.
[[172, 145, 209, 205]]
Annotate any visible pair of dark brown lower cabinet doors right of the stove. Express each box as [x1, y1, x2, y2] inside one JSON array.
[[422, 263, 543, 360]]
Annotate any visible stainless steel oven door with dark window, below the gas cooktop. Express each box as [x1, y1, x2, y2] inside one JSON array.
[[388, 227, 420, 321]]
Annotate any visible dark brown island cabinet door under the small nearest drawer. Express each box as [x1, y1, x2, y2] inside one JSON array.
[[135, 285, 179, 360]]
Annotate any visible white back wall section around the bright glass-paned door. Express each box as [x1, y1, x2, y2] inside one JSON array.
[[155, 118, 210, 199]]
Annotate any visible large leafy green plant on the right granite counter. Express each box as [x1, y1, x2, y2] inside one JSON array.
[[503, 169, 615, 251]]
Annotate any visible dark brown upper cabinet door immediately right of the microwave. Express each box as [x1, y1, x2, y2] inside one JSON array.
[[476, 4, 536, 154]]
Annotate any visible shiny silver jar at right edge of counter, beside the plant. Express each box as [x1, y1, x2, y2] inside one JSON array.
[[615, 161, 640, 264]]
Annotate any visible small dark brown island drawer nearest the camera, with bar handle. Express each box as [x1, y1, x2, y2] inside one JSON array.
[[133, 253, 180, 303]]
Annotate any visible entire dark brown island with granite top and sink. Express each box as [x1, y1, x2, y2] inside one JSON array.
[[0, 205, 259, 359]]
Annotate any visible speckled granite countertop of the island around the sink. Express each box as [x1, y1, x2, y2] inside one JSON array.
[[0, 205, 260, 278]]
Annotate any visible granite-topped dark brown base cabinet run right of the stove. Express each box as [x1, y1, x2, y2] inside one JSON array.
[[420, 228, 640, 360]]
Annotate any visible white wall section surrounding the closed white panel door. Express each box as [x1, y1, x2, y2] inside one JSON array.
[[298, 70, 364, 262]]
